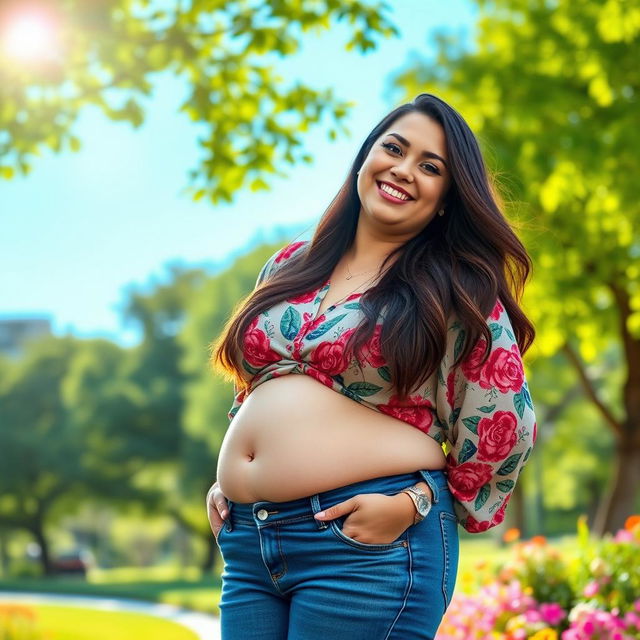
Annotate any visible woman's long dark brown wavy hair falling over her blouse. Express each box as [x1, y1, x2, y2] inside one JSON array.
[[211, 93, 535, 398]]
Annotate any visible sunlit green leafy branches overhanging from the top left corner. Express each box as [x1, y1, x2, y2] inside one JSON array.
[[0, 0, 398, 203]]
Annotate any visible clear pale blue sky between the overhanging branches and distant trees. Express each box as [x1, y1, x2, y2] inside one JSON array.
[[0, 0, 476, 345]]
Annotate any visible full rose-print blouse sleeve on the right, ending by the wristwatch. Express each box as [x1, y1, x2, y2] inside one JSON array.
[[436, 300, 536, 533]]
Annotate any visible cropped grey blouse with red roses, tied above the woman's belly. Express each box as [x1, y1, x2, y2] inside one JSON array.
[[229, 241, 536, 533]]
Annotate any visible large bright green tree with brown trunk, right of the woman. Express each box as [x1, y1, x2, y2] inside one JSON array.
[[394, 0, 640, 533]]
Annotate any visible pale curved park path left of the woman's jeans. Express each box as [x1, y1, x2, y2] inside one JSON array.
[[0, 591, 220, 640]]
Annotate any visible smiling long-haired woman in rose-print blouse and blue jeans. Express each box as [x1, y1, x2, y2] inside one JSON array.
[[207, 94, 536, 640]]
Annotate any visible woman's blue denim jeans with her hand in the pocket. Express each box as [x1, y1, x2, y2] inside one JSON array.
[[218, 470, 458, 640]]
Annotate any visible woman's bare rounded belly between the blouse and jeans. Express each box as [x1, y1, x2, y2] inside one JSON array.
[[217, 374, 446, 502]]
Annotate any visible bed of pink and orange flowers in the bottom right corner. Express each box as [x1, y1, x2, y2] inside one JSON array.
[[436, 516, 640, 640]]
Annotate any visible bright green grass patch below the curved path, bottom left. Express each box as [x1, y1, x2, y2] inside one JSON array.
[[0, 605, 198, 640]]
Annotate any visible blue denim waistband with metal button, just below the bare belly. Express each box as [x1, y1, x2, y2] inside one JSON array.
[[227, 469, 447, 527]]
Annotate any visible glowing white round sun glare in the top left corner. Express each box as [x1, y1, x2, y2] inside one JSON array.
[[0, 10, 59, 62]]
